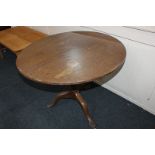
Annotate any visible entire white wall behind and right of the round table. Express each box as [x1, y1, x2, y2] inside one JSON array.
[[29, 26, 155, 114]]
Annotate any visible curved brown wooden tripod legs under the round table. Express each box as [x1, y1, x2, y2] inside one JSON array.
[[48, 90, 96, 128]]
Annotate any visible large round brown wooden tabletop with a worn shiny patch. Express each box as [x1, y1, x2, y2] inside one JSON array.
[[16, 31, 126, 85]]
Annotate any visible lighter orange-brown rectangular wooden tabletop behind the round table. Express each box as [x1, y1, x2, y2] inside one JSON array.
[[0, 26, 47, 55]]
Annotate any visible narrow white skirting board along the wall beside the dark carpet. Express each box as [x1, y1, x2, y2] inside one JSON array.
[[94, 81, 155, 115]]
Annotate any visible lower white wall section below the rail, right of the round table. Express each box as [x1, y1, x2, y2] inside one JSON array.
[[98, 37, 155, 114]]
